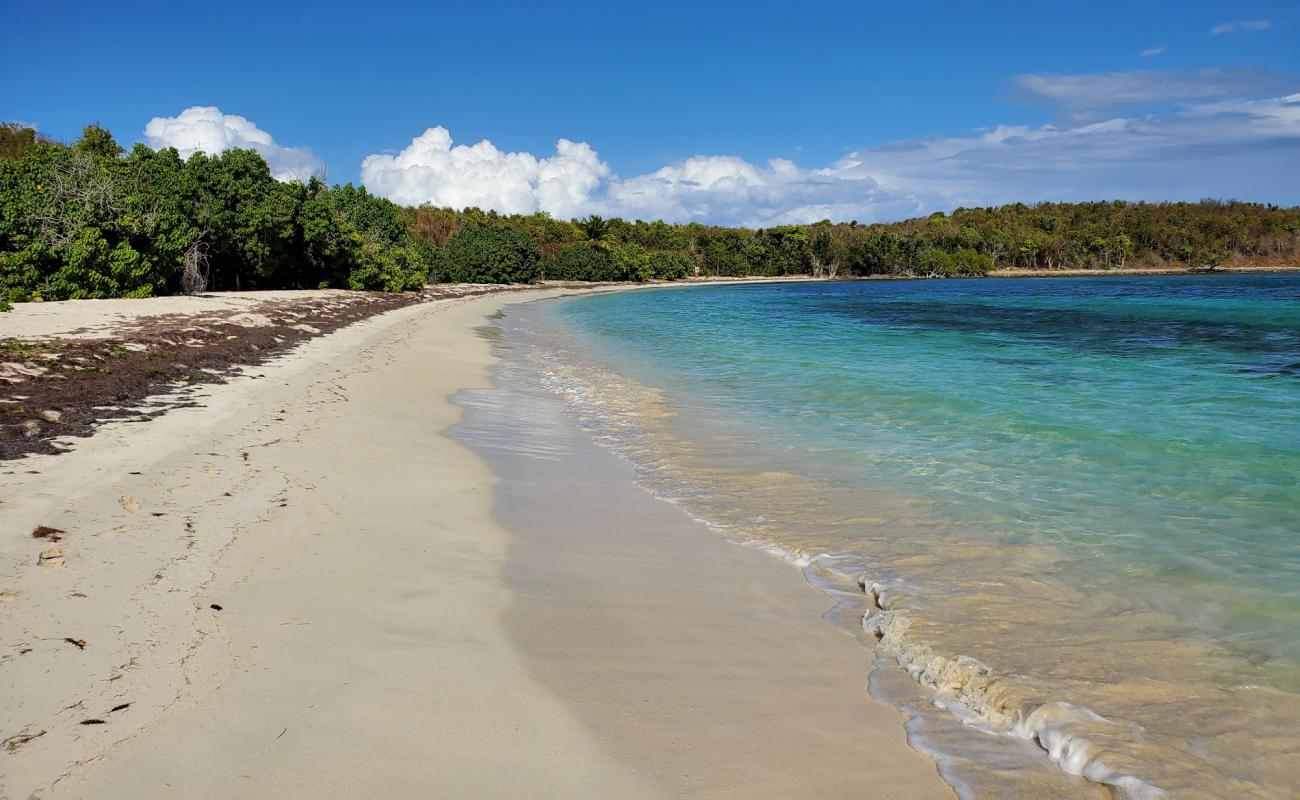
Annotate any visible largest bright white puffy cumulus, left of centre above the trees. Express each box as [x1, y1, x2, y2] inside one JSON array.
[[361, 126, 610, 217]]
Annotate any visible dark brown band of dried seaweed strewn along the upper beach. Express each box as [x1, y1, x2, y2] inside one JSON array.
[[0, 284, 579, 460]]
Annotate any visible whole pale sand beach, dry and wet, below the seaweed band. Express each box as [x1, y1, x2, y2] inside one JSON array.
[[0, 290, 952, 799]]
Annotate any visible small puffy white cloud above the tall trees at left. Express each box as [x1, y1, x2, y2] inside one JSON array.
[[144, 105, 325, 181]]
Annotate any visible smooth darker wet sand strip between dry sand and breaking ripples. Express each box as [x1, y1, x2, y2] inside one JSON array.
[[454, 335, 952, 797]]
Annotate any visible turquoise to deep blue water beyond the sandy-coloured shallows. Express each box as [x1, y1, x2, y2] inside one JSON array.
[[563, 274, 1300, 658]]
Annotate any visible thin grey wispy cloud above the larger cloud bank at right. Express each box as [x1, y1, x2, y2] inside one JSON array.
[[1014, 66, 1300, 120]]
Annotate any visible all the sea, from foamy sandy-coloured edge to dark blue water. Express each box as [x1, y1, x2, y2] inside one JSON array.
[[491, 274, 1300, 797]]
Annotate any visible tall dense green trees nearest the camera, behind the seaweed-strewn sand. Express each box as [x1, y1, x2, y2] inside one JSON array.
[[0, 125, 430, 300]]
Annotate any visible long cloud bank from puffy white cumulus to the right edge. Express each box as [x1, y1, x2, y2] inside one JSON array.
[[361, 92, 1300, 226]]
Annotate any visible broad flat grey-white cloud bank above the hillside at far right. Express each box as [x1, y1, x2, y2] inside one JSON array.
[[836, 95, 1300, 209]]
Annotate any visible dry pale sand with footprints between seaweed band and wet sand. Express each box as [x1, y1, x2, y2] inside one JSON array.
[[0, 289, 952, 797]]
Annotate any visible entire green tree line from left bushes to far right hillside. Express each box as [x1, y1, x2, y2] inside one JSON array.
[[0, 124, 1300, 307]]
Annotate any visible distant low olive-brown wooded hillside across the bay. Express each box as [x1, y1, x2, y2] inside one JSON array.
[[402, 200, 1300, 281]]
